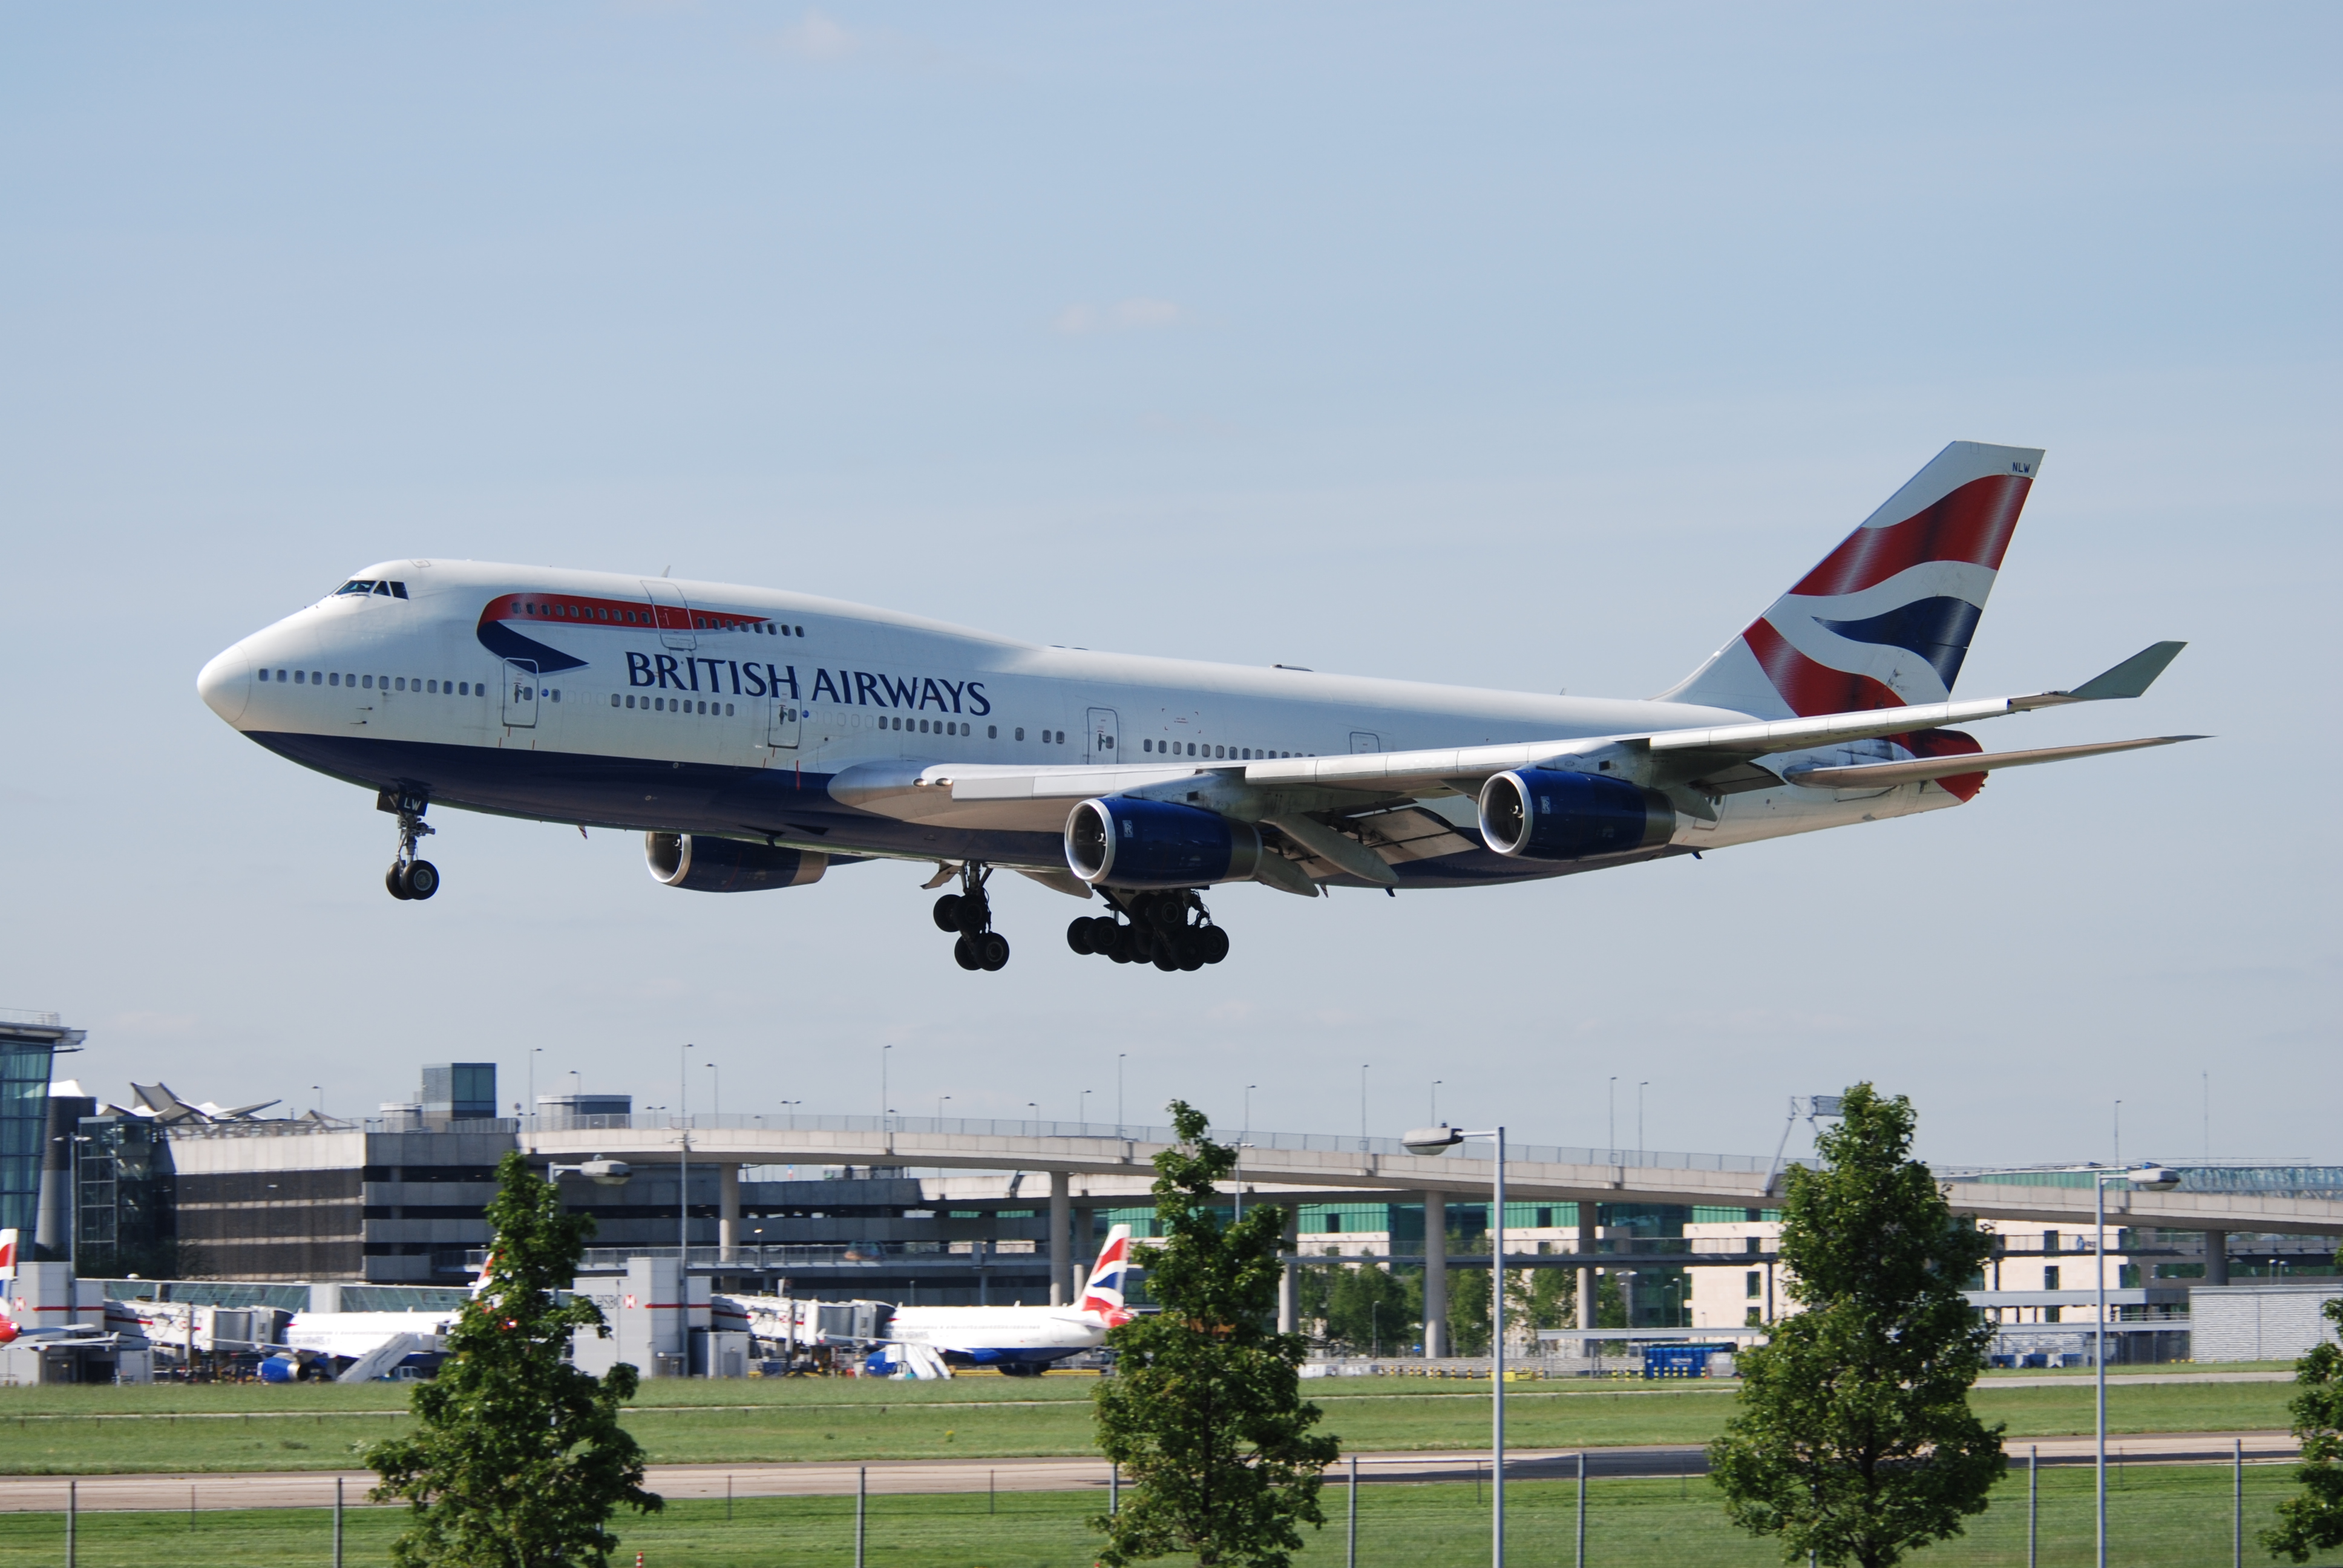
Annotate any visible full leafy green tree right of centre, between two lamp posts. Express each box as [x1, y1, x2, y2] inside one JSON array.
[[1708, 1083, 2008, 1568]]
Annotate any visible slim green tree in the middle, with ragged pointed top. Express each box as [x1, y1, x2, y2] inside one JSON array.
[[1089, 1099, 1338, 1568]]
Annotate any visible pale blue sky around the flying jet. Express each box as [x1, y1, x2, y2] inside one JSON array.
[[0, 2, 2343, 1160]]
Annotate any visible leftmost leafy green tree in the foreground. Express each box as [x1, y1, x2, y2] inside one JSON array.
[[365, 1151, 663, 1568]]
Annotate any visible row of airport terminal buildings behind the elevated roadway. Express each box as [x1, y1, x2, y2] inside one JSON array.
[[22, 1015, 2343, 1359]]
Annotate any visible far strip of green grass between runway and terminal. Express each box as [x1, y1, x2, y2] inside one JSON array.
[[0, 1378, 2292, 1474]]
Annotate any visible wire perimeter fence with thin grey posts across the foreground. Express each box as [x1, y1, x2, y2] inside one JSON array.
[[0, 1448, 2343, 1568]]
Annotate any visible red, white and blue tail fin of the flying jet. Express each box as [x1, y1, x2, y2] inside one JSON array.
[[1661, 440, 2043, 719]]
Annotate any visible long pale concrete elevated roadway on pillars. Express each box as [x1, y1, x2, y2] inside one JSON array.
[[520, 1116, 2343, 1350]]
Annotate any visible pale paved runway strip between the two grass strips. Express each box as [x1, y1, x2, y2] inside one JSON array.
[[0, 1432, 2301, 1514]]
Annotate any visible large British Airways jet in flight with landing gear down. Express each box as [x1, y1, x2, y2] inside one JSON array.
[[197, 440, 2198, 970]]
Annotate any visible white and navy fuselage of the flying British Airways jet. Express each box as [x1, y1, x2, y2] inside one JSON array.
[[199, 560, 1954, 886]]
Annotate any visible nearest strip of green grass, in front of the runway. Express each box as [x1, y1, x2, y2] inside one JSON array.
[[0, 1465, 2343, 1568]]
